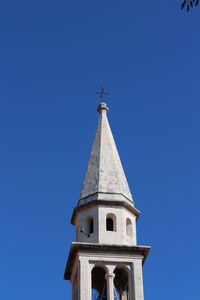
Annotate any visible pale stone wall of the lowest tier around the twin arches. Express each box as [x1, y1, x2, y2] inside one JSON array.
[[71, 248, 144, 300]]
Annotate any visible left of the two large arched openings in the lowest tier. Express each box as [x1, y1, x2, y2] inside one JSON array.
[[92, 266, 107, 300]]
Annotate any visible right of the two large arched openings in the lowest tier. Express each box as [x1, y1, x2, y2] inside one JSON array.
[[114, 267, 129, 300]]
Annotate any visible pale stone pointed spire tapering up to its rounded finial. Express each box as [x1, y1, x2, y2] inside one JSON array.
[[79, 102, 133, 205]]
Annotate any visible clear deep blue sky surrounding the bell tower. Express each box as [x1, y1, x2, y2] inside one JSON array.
[[0, 0, 200, 300]]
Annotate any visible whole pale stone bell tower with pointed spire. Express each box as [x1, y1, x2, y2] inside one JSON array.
[[64, 102, 150, 300]]
